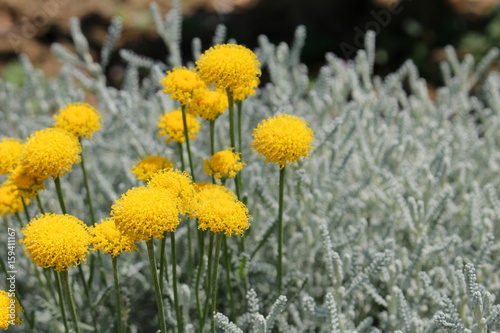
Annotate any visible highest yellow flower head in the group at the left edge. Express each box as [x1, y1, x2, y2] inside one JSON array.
[[54, 103, 101, 139]]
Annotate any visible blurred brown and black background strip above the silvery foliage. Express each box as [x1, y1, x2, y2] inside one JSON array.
[[0, 0, 500, 86]]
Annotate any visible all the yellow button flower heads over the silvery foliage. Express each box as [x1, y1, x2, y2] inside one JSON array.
[[0, 40, 314, 327]]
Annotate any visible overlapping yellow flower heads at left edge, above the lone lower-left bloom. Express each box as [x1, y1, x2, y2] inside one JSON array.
[[0, 103, 101, 216]]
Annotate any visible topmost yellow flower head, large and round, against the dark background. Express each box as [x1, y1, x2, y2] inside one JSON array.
[[196, 44, 261, 91]]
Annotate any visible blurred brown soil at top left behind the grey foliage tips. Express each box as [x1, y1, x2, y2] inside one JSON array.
[[0, 0, 256, 76]]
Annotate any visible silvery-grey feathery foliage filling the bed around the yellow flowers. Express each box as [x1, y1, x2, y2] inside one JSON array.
[[0, 2, 500, 333]]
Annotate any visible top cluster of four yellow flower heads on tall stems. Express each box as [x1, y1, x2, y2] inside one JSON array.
[[158, 44, 261, 143]]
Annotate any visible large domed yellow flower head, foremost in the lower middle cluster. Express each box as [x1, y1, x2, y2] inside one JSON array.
[[111, 186, 180, 242]]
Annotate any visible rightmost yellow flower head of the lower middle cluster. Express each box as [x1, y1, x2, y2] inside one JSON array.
[[192, 185, 252, 236]]
